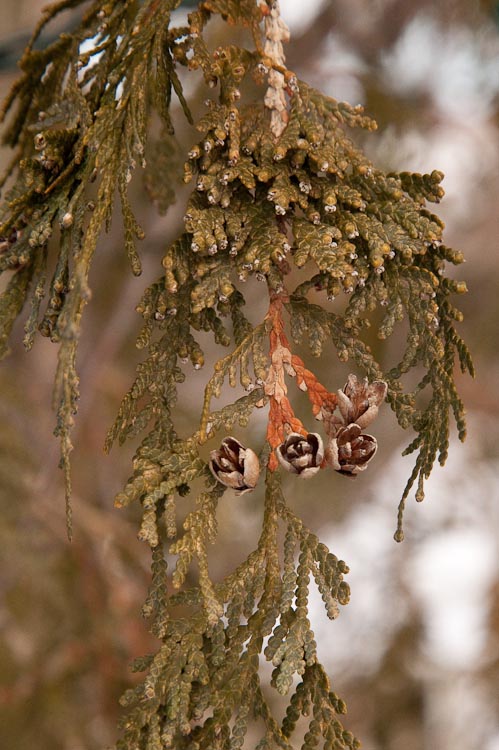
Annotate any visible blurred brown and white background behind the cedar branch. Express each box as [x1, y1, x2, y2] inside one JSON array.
[[0, 0, 499, 750]]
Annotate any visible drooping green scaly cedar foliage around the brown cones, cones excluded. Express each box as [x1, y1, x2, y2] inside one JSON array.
[[0, 0, 472, 750]]
